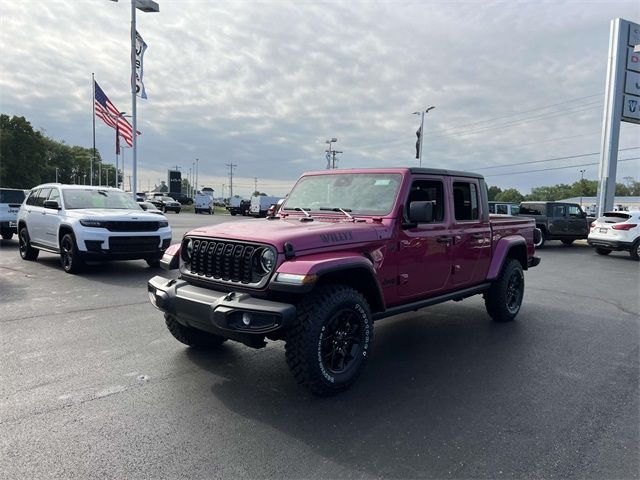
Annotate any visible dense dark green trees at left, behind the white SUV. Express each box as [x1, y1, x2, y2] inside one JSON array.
[[0, 114, 122, 189]]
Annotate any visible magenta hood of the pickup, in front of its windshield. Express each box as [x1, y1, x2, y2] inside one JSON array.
[[188, 218, 379, 252]]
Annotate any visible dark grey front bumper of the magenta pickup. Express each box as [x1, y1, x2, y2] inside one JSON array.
[[147, 276, 296, 338]]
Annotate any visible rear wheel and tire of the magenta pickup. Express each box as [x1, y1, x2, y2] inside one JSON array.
[[484, 258, 524, 323]]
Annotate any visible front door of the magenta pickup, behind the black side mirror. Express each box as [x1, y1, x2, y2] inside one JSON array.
[[398, 176, 451, 300]]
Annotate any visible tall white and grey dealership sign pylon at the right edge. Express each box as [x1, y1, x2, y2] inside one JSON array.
[[598, 18, 640, 216]]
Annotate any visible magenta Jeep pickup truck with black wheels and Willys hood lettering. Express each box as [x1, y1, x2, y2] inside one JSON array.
[[148, 168, 540, 395]]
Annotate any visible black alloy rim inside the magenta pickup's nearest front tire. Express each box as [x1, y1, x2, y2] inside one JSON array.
[[320, 309, 364, 374]]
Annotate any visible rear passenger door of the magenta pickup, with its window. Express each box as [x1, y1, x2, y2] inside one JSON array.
[[449, 177, 491, 289]]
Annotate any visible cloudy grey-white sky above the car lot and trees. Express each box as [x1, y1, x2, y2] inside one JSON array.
[[0, 0, 640, 194]]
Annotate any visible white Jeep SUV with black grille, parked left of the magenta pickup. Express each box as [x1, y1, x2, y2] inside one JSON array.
[[18, 183, 171, 273]]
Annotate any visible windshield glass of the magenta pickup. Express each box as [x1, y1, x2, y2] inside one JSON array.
[[283, 173, 402, 215]]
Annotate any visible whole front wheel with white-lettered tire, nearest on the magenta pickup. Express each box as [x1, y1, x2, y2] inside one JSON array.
[[285, 285, 373, 396]]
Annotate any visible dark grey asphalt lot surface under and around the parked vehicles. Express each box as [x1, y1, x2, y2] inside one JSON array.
[[0, 213, 640, 479]]
